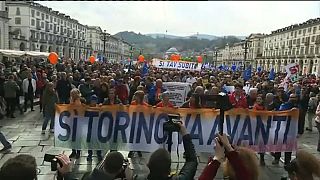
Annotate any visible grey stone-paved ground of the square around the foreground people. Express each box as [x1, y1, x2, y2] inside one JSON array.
[[0, 108, 320, 180]]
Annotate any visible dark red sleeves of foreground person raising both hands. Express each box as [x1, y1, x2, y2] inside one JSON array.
[[199, 151, 253, 180]]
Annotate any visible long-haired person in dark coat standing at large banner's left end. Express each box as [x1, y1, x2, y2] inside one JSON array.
[[41, 82, 59, 134]]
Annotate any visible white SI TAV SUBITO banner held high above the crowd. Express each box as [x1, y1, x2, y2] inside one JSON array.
[[152, 59, 202, 71]]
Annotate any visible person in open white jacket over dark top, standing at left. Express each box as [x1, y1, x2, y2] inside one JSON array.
[[22, 73, 36, 112]]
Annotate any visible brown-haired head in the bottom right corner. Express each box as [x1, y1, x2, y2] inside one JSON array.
[[285, 150, 320, 180]]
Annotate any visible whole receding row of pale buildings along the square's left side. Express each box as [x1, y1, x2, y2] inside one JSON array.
[[5, 1, 129, 60]]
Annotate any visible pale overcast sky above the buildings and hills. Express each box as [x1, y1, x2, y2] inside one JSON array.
[[38, 1, 320, 36]]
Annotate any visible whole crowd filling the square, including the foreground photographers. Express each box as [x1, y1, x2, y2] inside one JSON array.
[[0, 58, 320, 180]]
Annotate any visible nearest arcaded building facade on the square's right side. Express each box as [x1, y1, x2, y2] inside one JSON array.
[[257, 18, 320, 75]]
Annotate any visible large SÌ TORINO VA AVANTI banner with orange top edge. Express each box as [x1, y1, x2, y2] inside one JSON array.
[[55, 105, 299, 152]]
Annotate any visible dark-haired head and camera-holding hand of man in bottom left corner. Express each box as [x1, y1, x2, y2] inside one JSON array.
[[0, 154, 73, 180]]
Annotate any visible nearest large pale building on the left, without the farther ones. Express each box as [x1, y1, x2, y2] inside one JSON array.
[[6, 1, 88, 59]]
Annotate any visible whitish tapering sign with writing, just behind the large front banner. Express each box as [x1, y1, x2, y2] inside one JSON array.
[[163, 82, 190, 107]]
